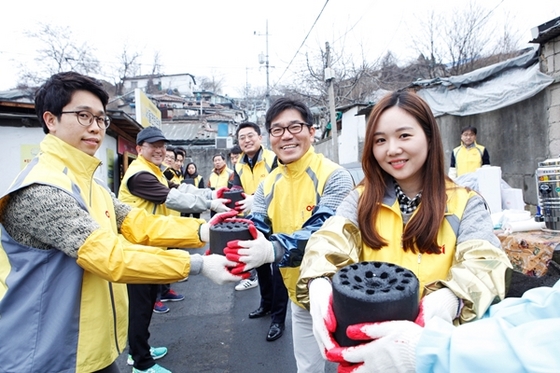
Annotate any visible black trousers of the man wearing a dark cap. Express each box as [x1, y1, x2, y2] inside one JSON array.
[[127, 284, 160, 370]]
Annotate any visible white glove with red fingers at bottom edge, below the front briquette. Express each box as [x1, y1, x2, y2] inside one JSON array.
[[329, 320, 422, 373]]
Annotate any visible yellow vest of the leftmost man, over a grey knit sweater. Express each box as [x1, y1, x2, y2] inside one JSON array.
[[1, 135, 128, 373]]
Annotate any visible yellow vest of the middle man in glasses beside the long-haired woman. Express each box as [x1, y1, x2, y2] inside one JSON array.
[[263, 147, 340, 308]]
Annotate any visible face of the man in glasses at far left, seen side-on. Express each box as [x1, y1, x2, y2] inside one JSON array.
[[43, 90, 105, 156]]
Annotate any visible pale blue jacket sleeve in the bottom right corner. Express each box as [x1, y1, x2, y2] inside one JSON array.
[[416, 281, 560, 373]]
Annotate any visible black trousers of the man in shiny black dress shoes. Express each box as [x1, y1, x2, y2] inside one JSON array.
[[257, 263, 289, 324]]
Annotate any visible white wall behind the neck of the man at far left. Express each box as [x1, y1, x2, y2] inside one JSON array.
[[0, 127, 118, 195]]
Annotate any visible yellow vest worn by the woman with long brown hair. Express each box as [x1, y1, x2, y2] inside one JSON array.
[[358, 183, 476, 296]]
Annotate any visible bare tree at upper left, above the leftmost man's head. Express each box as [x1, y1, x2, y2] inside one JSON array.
[[20, 24, 100, 84]]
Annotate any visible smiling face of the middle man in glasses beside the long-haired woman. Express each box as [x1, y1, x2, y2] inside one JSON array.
[[270, 109, 315, 164]]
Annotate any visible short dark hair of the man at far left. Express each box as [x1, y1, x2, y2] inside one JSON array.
[[35, 71, 109, 133]]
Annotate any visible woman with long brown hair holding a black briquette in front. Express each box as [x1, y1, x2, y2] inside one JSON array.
[[297, 91, 512, 372]]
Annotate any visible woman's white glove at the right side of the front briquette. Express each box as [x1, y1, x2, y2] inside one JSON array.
[[415, 288, 461, 326]]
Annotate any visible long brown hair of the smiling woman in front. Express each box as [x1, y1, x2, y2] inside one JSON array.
[[358, 91, 448, 253]]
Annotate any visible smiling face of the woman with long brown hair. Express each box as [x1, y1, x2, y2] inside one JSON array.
[[373, 106, 428, 197]]
